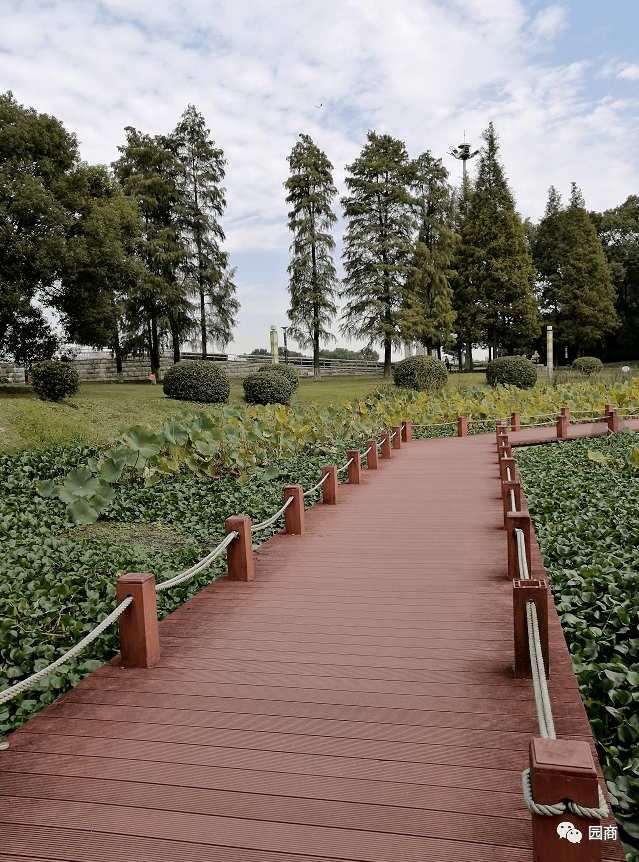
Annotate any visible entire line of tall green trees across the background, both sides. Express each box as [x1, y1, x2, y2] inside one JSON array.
[[0, 93, 639, 378]]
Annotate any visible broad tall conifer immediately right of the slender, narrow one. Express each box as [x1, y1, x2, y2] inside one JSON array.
[[341, 131, 417, 377]]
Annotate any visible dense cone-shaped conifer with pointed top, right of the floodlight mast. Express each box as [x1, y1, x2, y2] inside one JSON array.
[[456, 123, 540, 355]]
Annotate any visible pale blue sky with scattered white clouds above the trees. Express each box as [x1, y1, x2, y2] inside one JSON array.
[[0, 0, 639, 353]]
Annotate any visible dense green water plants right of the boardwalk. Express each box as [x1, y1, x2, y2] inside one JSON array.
[[514, 431, 639, 862]]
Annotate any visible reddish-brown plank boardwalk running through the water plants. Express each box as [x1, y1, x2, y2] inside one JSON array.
[[0, 434, 624, 862]]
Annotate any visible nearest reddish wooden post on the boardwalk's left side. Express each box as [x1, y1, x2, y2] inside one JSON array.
[[115, 572, 160, 667]]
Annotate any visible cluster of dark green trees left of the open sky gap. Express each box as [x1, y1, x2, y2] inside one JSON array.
[[0, 93, 239, 374]]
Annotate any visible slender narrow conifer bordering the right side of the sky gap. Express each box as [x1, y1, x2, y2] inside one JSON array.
[[284, 135, 338, 380]]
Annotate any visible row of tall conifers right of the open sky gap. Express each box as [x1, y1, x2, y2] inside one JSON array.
[[285, 123, 639, 378]]
